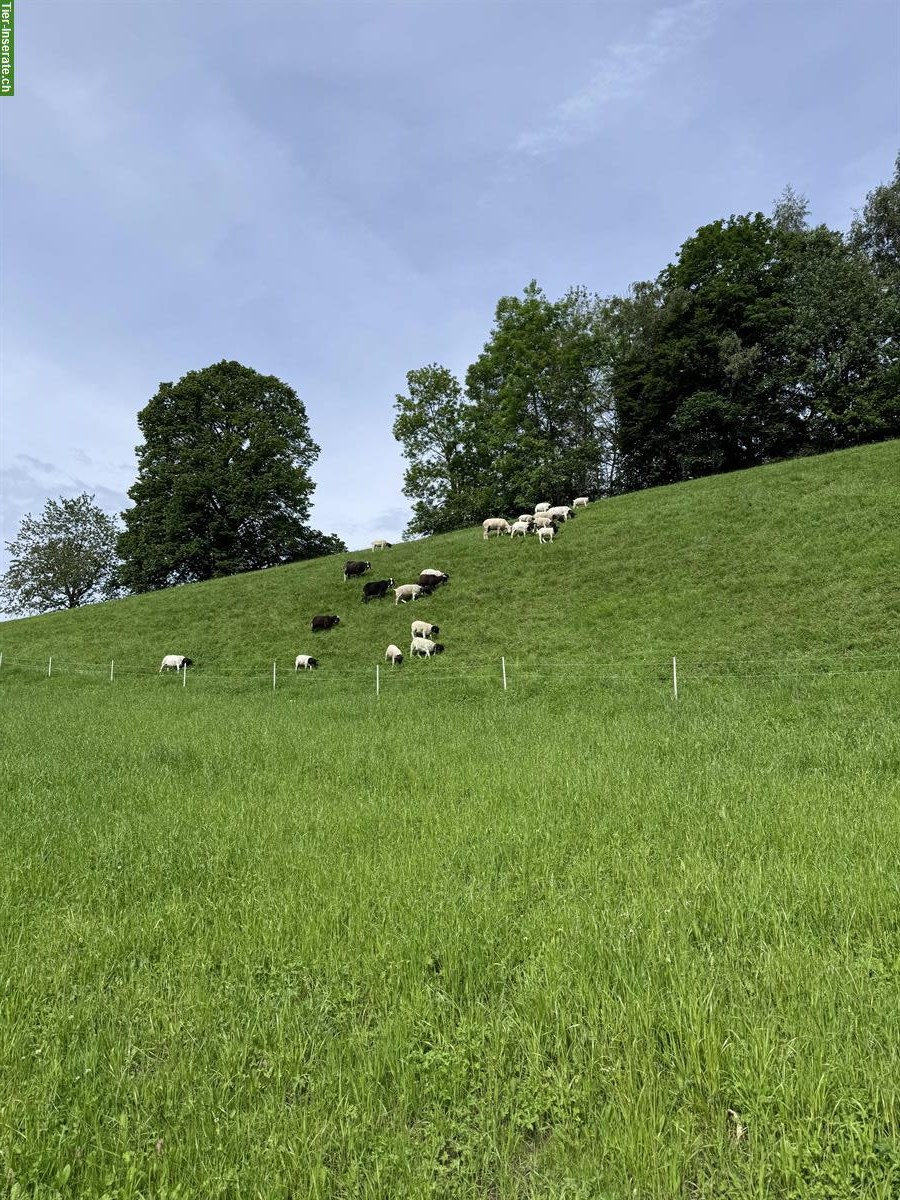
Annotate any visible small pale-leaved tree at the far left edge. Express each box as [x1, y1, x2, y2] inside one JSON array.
[[0, 492, 119, 614]]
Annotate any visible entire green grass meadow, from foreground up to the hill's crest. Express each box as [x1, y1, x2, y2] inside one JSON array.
[[0, 442, 900, 1200]]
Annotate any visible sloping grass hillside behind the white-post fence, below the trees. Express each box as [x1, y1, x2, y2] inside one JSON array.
[[0, 442, 900, 674]]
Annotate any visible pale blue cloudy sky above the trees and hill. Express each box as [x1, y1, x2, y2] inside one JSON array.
[[0, 0, 900, 585]]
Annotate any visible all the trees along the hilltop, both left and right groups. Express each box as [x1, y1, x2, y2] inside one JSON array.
[[0, 155, 900, 613]]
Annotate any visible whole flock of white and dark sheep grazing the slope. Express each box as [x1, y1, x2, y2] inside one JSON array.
[[160, 496, 588, 672]]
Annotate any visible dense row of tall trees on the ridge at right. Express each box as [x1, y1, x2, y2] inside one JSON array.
[[394, 156, 900, 535]]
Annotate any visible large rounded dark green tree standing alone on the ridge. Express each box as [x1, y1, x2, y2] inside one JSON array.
[[119, 360, 343, 592]]
